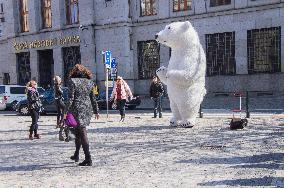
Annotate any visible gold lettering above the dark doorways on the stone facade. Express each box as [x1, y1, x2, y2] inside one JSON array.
[[13, 35, 80, 51]]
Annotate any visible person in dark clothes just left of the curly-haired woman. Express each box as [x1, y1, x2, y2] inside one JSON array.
[[53, 76, 70, 142]]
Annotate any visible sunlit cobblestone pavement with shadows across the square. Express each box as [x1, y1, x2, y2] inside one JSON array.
[[0, 112, 284, 188]]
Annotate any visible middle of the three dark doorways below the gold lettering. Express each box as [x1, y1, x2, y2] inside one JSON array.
[[38, 50, 54, 89]]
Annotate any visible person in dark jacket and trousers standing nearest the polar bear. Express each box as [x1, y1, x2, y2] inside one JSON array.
[[150, 76, 164, 118]]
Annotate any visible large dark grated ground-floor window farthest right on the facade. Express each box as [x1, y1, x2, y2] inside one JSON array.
[[247, 27, 281, 74]]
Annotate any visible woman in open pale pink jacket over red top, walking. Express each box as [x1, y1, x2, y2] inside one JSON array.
[[110, 76, 133, 122]]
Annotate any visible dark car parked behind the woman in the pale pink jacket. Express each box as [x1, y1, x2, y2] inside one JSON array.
[[97, 91, 141, 110]]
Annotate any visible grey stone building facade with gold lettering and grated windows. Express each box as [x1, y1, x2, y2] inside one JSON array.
[[0, 0, 284, 95]]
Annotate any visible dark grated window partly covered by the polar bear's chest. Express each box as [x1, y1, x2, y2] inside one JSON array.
[[138, 40, 160, 79]]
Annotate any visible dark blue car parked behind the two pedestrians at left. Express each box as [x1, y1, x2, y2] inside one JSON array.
[[16, 87, 68, 115]]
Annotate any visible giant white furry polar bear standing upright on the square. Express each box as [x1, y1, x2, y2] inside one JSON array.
[[156, 21, 206, 127]]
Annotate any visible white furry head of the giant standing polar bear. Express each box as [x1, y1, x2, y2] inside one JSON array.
[[155, 21, 199, 48]]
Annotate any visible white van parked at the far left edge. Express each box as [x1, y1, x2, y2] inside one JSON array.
[[0, 85, 44, 110]]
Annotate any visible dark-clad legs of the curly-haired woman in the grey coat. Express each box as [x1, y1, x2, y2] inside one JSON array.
[[74, 126, 91, 161]]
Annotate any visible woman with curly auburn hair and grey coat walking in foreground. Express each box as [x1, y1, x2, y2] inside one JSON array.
[[65, 64, 99, 166]]
